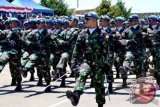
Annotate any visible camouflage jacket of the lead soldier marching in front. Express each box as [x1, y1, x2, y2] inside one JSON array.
[[71, 27, 109, 66]]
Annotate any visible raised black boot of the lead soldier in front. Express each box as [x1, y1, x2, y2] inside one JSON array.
[[66, 90, 82, 106]]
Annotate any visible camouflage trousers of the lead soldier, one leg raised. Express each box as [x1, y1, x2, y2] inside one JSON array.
[[75, 63, 105, 104]]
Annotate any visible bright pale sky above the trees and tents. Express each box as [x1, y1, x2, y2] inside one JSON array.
[[34, 0, 160, 13]]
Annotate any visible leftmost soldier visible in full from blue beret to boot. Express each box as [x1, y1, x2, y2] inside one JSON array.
[[7, 18, 22, 91]]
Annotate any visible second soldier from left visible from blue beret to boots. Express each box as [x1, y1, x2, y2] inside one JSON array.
[[34, 18, 51, 85]]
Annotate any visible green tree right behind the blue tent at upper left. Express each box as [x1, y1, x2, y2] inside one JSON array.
[[41, 0, 68, 16]]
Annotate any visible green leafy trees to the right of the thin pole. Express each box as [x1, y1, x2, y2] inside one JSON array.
[[96, 0, 131, 18]]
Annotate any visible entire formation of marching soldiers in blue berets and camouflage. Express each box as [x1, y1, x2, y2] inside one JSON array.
[[0, 12, 160, 107]]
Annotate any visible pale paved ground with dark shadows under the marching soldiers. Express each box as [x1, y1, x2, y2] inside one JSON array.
[[0, 65, 160, 107]]
